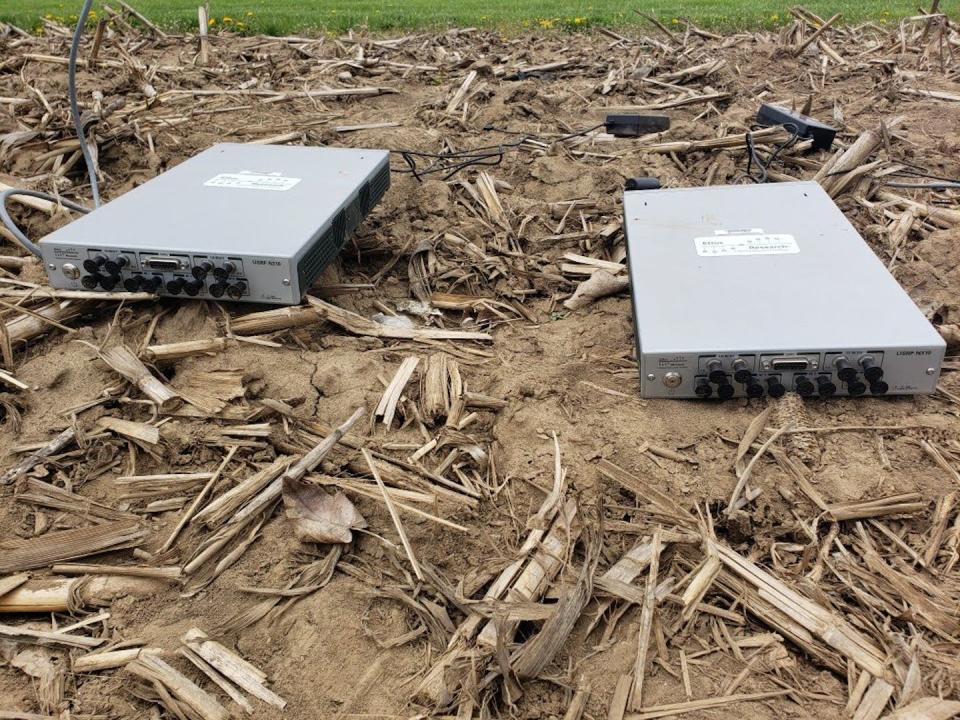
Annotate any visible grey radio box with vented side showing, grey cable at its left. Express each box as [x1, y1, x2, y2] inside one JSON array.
[[40, 144, 390, 305]]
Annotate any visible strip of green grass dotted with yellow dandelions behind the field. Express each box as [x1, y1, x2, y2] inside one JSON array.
[[0, 0, 936, 35]]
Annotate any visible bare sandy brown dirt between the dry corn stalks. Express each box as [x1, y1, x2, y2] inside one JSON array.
[[0, 15, 960, 720]]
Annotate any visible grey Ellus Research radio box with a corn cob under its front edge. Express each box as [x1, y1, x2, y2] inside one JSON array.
[[624, 182, 946, 399]]
